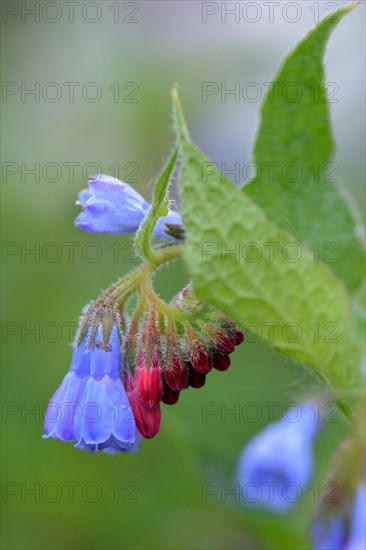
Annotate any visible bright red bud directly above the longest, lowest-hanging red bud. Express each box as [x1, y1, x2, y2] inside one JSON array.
[[137, 348, 163, 409]]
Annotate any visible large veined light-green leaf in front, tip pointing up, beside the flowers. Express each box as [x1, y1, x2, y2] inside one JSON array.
[[174, 88, 360, 404]]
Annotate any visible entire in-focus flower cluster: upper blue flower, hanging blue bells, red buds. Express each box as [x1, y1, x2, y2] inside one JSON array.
[[44, 175, 244, 453]]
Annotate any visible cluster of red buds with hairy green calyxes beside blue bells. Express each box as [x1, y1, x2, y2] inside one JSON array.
[[122, 288, 244, 438]]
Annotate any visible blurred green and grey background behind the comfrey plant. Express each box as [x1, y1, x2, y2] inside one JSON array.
[[1, 0, 365, 550]]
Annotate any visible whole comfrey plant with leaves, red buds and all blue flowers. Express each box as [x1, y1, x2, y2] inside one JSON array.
[[44, 5, 366, 550]]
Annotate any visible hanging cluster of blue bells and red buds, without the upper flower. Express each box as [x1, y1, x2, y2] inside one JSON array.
[[44, 288, 244, 452]]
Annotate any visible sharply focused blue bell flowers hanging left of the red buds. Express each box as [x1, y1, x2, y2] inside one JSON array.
[[43, 326, 141, 453]]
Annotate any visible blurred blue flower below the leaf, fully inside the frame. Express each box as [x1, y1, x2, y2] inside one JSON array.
[[238, 403, 319, 513]]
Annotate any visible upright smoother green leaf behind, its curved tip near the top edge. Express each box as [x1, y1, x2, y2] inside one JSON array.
[[244, 6, 364, 291]]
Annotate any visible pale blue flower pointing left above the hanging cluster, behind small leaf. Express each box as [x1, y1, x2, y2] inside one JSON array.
[[75, 174, 182, 239]]
